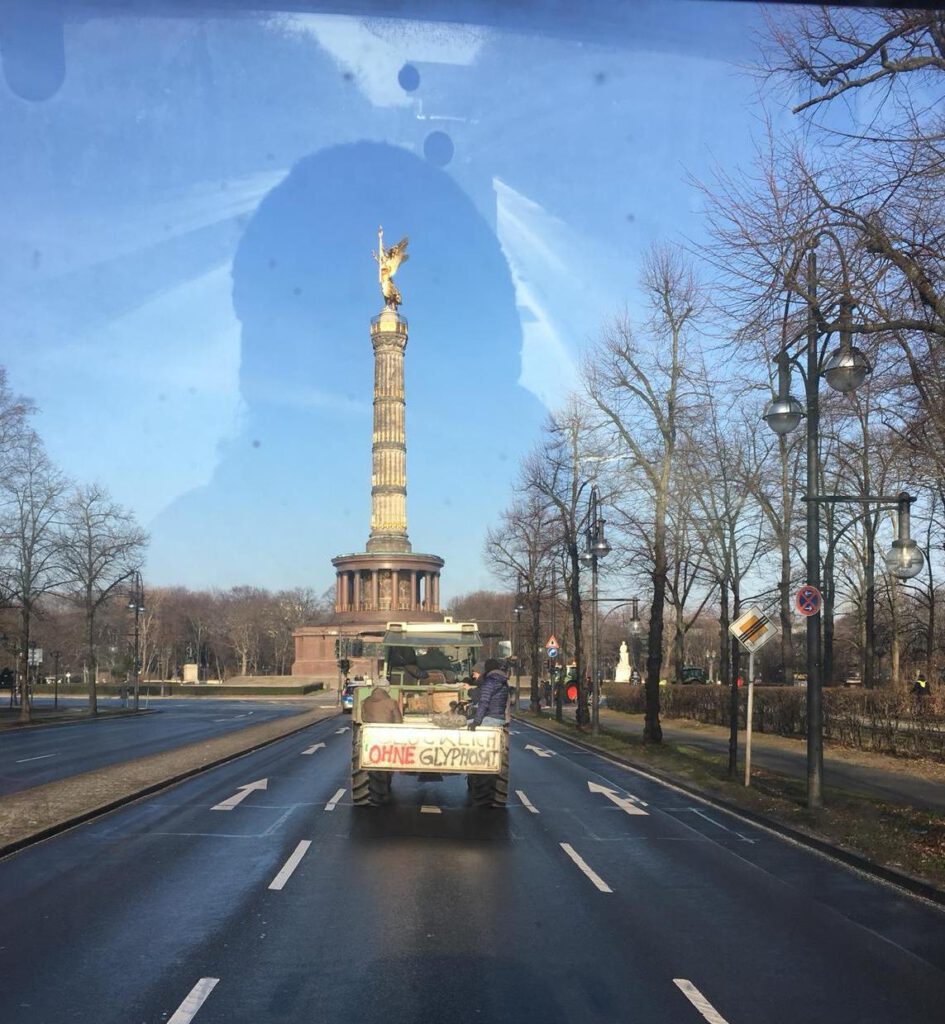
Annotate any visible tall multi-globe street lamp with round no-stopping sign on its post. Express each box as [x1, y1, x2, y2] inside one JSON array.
[[763, 230, 922, 807]]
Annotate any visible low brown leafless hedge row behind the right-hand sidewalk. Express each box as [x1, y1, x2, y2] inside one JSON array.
[[607, 686, 945, 760]]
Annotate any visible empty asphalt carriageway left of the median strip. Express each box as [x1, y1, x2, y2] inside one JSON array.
[[0, 694, 335, 794]]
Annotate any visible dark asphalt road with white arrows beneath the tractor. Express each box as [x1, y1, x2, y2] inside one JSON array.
[[0, 718, 945, 1024]]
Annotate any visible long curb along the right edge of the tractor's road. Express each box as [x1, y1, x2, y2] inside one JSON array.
[[516, 716, 945, 908]]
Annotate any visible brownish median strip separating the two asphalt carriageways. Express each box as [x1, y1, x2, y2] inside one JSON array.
[[0, 709, 333, 857]]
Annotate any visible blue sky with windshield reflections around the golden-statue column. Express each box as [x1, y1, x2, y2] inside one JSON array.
[[0, 2, 774, 599]]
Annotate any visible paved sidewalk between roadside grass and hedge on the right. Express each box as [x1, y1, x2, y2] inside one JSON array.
[[543, 708, 945, 812]]
